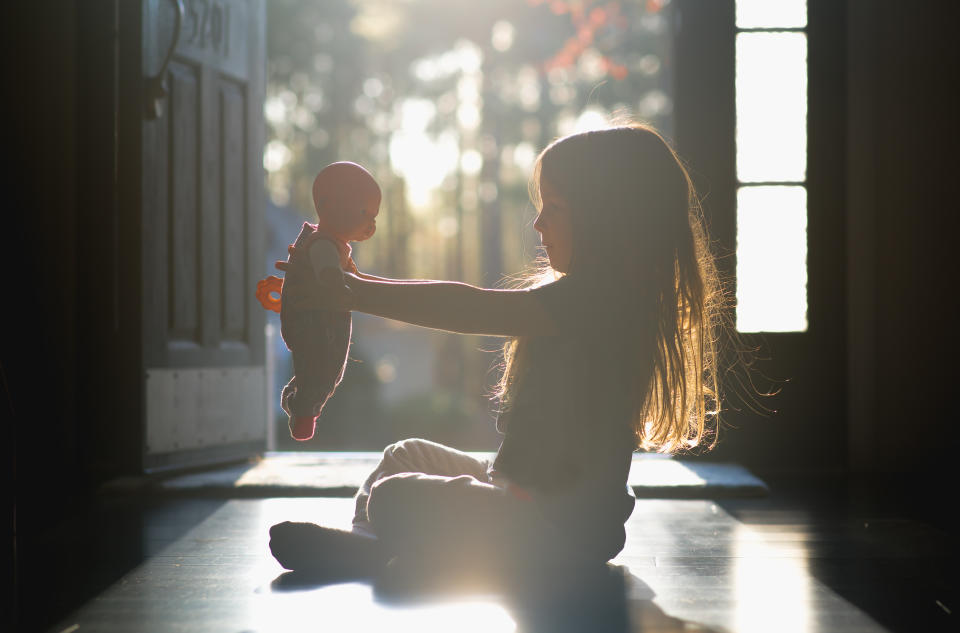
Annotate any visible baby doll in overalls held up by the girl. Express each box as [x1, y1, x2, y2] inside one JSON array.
[[261, 162, 381, 441]]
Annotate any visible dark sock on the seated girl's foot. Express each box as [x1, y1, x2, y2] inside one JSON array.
[[270, 521, 388, 578]]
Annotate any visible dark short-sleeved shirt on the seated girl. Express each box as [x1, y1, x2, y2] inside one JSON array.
[[491, 275, 634, 555]]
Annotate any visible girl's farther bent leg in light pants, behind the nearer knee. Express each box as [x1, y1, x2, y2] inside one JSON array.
[[353, 439, 489, 532]]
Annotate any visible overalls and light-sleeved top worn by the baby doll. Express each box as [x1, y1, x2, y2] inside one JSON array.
[[280, 222, 356, 440]]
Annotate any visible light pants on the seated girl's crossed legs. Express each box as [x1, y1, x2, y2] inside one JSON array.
[[353, 439, 606, 573]]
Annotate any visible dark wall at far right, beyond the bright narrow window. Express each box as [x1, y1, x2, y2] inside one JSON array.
[[847, 0, 960, 472]]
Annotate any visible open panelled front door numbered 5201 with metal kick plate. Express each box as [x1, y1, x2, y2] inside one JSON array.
[[141, 0, 267, 470]]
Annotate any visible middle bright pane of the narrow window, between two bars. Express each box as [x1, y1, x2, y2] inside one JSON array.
[[737, 33, 807, 182]]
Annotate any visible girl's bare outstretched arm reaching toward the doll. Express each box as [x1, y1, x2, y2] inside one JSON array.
[[344, 274, 556, 336]]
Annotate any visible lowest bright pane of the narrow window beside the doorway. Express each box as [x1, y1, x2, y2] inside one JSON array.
[[737, 186, 807, 332]]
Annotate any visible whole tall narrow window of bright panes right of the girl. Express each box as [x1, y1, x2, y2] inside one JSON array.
[[736, 0, 807, 332]]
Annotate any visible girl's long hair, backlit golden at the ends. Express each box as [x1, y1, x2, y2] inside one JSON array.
[[496, 124, 725, 452]]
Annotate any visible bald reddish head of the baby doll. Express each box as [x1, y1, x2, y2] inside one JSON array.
[[313, 162, 380, 242]]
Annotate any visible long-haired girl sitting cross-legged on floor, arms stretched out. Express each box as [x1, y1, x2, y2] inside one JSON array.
[[271, 125, 721, 574]]
